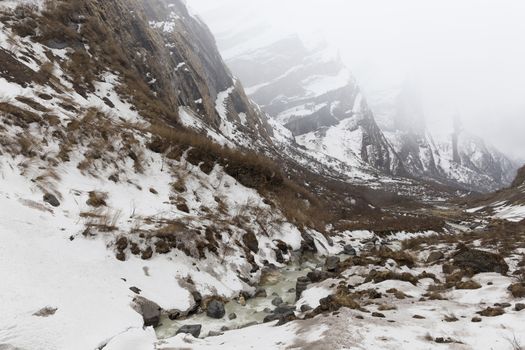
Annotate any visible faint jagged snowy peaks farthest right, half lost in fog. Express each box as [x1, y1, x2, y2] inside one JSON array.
[[375, 84, 516, 192]]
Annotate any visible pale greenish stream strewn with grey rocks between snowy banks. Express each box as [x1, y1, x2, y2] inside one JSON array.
[[156, 250, 356, 339]]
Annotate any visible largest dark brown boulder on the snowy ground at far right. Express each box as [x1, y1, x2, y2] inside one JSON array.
[[453, 248, 509, 275]]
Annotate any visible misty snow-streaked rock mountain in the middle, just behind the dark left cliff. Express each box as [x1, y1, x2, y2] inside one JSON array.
[[215, 31, 404, 175]]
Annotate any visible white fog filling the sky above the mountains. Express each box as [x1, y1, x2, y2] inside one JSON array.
[[187, 0, 525, 160]]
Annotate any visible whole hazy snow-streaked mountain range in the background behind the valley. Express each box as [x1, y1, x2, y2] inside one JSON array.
[[198, 6, 516, 192]]
